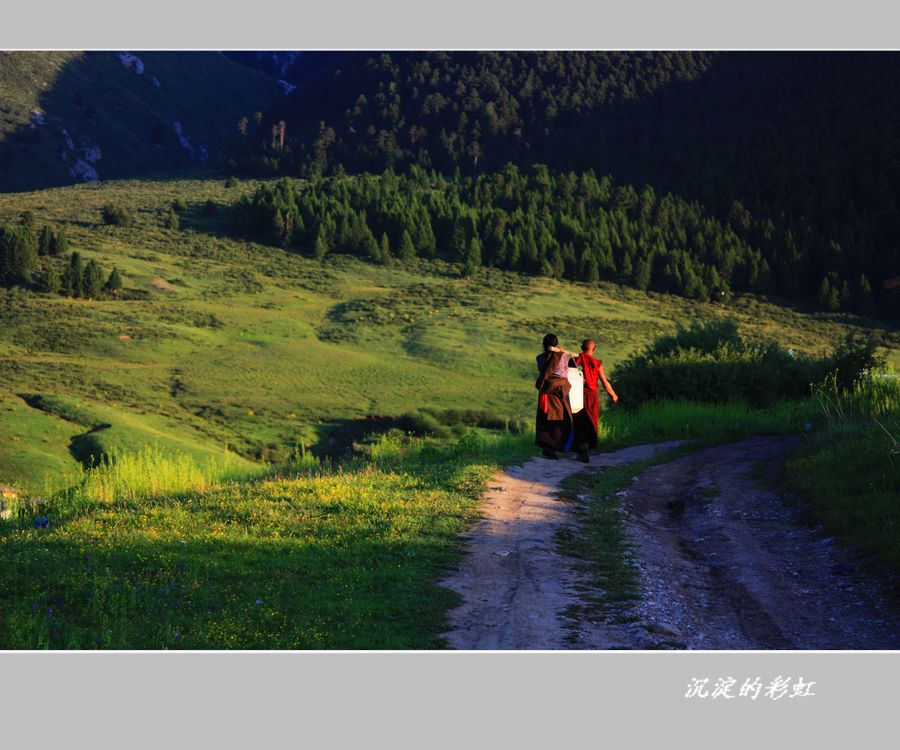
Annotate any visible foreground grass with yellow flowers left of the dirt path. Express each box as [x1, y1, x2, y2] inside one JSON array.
[[0, 433, 529, 649]]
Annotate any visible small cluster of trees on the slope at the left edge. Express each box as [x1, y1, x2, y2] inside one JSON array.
[[0, 212, 122, 298]]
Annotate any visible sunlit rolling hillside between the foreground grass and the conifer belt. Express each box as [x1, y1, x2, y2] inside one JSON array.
[[0, 174, 900, 491]]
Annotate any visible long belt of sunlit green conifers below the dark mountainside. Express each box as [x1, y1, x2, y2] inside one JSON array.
[[233, 165, 792, 300]]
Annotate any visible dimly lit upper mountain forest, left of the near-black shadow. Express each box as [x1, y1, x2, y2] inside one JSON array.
[[226, 52, 714, 175]]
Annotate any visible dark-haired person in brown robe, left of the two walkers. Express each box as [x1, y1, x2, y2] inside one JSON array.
[[534, 333, 574, 458]]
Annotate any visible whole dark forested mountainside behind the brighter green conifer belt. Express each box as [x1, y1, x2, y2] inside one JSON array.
[[226, 52, 900, 318]]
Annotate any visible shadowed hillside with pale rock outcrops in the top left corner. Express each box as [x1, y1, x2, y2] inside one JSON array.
[[0, 51, 281, 191]]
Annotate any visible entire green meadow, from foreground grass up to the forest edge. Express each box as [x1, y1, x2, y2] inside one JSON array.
[[0, 173, 900, 648]]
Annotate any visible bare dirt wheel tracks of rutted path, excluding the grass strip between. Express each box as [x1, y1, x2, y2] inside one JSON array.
[[445, 437, 900, 649]]
